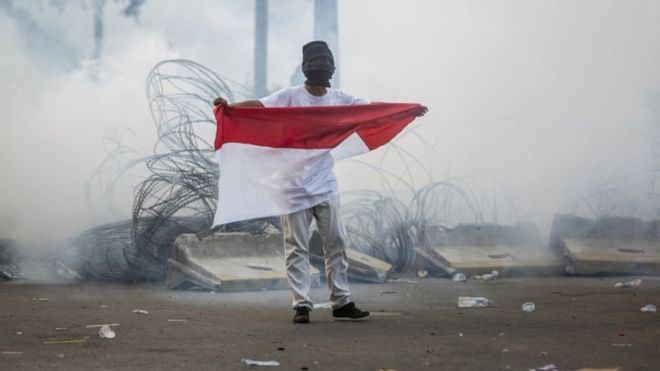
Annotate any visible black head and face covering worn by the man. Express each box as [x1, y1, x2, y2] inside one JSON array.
[[302, 41, 335, 88]]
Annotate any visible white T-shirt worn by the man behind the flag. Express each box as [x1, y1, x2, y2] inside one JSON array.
[[259, 85, 369, 211]]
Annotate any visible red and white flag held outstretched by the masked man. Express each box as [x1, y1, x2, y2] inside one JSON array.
[[213, 103, 423, 226]]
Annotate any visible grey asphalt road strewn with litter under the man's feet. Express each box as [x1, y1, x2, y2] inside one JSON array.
[[0, 277, 660, 371]]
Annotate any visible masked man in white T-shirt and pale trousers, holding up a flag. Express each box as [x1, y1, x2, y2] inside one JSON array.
[[213, 41, 426, 323]]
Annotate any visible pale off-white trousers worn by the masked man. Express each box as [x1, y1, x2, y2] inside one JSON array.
[[282, 197, 351, 309]]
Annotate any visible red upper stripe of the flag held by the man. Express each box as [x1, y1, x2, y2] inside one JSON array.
[[215, 103, 422, 150]]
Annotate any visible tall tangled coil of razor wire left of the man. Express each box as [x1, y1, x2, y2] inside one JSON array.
[[72, 59, 279, 281]]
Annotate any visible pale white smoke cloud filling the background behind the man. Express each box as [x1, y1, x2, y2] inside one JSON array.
[[0, 0, 660, 244]]
